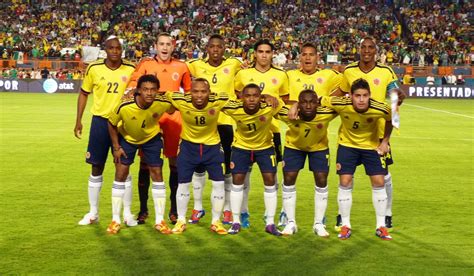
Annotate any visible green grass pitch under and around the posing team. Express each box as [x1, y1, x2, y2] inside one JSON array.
[[0, 93, 474, 275]]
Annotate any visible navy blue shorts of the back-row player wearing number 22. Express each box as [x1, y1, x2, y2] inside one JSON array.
[[86, 116, 112, 165]]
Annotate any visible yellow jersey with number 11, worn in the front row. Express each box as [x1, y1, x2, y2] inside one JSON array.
[[222, 100, 284, 150]]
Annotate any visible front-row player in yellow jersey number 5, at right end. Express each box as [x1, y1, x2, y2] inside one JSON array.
[[323, 79, 392, 240]]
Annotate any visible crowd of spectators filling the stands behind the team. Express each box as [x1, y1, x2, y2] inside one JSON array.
[[0, 0, 472, 65]]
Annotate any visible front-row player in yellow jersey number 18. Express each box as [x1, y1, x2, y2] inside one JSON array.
[[167, 78, 229, 235]]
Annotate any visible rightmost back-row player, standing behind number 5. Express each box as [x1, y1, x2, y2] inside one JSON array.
[[336, 37, 405, 228]]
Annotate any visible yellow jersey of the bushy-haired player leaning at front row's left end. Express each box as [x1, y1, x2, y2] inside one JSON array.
[[109, 95, 171, 145]]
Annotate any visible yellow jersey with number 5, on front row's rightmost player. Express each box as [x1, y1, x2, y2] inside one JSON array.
[[321, 97, 392, 150]]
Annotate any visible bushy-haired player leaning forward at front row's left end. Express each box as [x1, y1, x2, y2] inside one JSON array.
[[107, 75, 171, 234]]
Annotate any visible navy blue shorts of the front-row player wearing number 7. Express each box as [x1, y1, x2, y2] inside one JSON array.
[[283, 147, 329, 172]]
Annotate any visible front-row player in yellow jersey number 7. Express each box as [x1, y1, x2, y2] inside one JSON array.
[[278, 90, 337, 237]]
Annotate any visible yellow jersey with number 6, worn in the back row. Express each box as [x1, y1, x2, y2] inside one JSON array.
[[186, 58, 242, 125]]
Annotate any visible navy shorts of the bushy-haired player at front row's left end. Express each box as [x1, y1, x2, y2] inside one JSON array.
[[119, 134, 163, 167]]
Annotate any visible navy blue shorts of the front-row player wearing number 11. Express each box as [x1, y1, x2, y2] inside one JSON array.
[[230, 147, 277, 174]]
